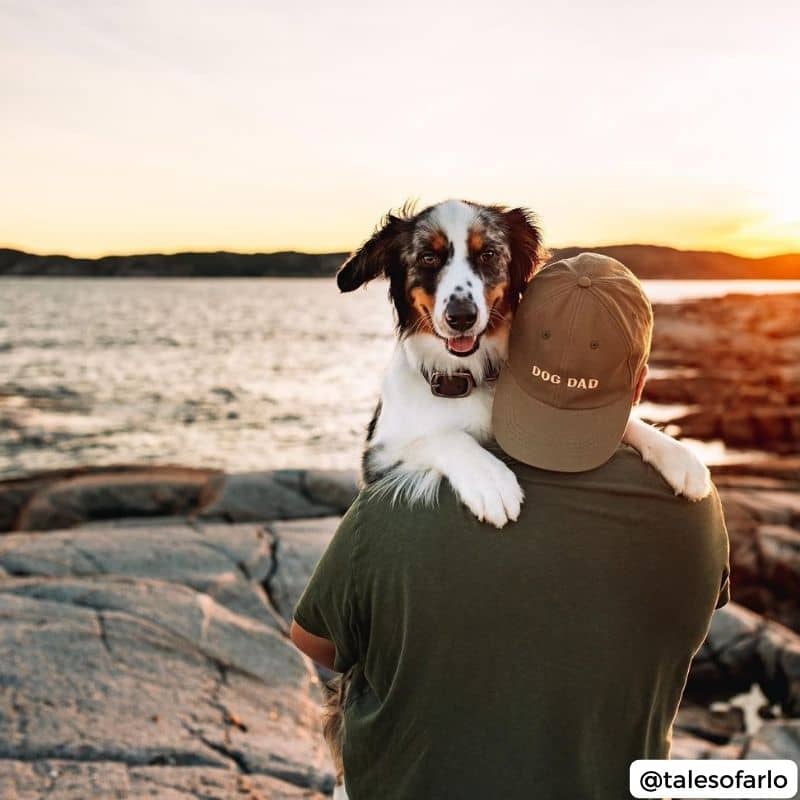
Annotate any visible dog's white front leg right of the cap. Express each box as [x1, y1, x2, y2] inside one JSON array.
[[622, 419, 711, 500]]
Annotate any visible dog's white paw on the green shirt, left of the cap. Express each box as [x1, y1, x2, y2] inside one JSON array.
[[447, 451, 525, 528]]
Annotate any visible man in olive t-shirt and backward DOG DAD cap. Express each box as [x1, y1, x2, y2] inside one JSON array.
[[292, 254, 728, 800]]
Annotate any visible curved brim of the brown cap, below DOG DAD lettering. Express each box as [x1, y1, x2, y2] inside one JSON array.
[[492, 367, 633, 472]]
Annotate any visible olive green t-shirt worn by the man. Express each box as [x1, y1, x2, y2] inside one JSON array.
[[295, 446, 728, 800]]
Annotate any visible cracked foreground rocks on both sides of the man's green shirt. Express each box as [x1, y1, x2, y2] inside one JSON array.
[[0, 459, 800, 800]]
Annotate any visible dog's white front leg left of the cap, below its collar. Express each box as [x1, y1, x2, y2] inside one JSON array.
[[390, 431, 524, 528]]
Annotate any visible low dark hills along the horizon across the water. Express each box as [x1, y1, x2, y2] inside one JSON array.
[[0, 244, 800, 280]]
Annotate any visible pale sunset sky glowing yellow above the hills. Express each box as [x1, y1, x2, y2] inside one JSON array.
[[0, 0, 800, 255]]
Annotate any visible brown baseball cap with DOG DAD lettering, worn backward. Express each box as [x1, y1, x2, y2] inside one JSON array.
[[492, 253, 653, 472]]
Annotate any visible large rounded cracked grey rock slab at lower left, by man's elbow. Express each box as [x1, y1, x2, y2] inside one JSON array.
[[0, 579, 327, 788]]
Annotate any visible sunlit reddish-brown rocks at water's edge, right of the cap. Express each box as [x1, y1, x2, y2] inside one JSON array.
[[645, 294, 800, 454]]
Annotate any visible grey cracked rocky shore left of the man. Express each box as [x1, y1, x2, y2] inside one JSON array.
[[0, 468, 355, 800]]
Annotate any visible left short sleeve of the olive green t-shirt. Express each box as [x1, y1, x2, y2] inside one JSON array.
[[294, 501, 359, 672]]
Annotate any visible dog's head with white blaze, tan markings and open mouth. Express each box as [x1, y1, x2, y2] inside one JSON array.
[[336, 200, 541, 358]]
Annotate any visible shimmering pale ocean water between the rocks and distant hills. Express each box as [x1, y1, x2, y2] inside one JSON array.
[[0, 278, 800, 477]]
